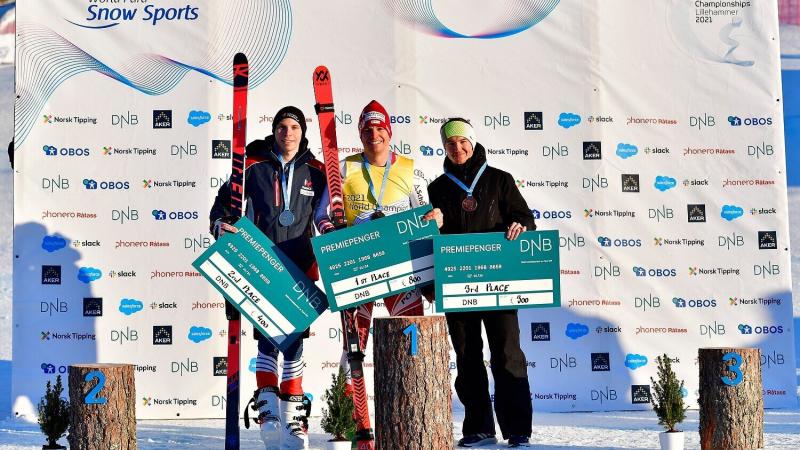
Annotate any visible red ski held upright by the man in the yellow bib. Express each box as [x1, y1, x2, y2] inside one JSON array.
[[313, 66, 375, 450]]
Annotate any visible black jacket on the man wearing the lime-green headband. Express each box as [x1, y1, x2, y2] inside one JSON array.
[[428, 144, 536, 234]]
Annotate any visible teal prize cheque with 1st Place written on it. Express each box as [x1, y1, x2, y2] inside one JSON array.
[[311, 206, 439, 311]]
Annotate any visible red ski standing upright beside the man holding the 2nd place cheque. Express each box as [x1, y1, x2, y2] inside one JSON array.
[[225, 53, 250, 450]]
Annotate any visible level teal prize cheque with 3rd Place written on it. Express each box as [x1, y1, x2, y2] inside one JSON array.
[[433, 230, 561, 312]]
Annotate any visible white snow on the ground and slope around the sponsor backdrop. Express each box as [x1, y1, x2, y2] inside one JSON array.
[[0, 58, 800, 450]]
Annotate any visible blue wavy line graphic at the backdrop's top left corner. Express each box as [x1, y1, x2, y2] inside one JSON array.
[[14, 0, 292, 145]]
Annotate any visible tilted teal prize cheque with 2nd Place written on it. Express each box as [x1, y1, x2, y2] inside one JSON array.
[[192, 217, 328, 351]]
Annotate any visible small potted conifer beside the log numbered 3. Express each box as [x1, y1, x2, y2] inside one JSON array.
[[650, 354, 686, 450]]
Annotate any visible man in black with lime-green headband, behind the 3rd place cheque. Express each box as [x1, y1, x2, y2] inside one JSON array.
[[428, 119, 536, 447]]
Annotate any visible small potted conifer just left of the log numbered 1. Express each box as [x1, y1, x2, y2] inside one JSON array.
[[322, 367, 356, 450]]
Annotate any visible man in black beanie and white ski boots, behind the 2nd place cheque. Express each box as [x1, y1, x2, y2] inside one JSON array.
[[210, 106, 333, 450]]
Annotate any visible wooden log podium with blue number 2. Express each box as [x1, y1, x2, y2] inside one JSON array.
[[67, 364, 136, 450]]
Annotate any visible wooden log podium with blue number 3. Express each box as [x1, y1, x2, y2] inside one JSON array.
[[698, 348, 764, 450]]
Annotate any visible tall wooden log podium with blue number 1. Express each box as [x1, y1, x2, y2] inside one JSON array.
[[373, 316, 453, 450]]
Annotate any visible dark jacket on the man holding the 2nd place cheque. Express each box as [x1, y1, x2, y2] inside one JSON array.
[[209, 136, 326, 271]]
